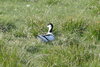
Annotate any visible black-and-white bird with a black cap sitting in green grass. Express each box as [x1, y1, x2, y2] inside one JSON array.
[[37, 23, 55, 42]]
